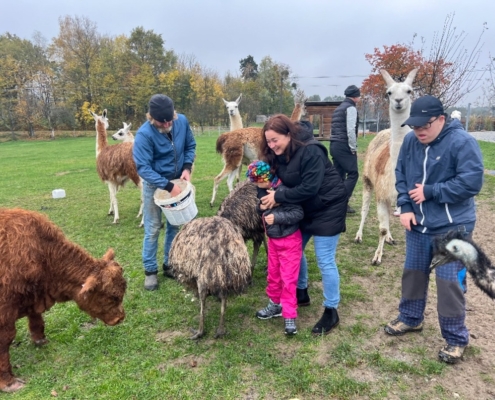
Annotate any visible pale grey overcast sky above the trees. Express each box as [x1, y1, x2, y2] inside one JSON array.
[[0, 0, 495, 104]]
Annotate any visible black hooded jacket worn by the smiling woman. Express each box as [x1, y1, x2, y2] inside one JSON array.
[[275, 121, 347, 236]]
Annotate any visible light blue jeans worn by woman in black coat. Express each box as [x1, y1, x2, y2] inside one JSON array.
[[297, 233, 340, 308]]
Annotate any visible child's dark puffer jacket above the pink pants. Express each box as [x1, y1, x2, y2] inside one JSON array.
[[256, 185, 304, 238]]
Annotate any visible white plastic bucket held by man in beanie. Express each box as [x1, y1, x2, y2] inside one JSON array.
[[153, 179, 198, 226]]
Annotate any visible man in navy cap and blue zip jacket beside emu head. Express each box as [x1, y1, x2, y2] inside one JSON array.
[[385, 96, 483, 363]]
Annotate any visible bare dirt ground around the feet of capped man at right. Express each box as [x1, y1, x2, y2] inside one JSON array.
[[348, 202, 495, 399]]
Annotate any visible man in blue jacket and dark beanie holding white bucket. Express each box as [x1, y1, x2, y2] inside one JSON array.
[[133, 94, 196, 290]]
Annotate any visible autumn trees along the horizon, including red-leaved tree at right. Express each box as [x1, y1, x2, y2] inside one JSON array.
[[0, 14, 483, 138]]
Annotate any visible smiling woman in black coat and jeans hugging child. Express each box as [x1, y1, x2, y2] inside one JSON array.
[[261, 114, 347, 336]]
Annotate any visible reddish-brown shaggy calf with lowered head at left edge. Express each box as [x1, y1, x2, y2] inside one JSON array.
[[0, 209, 126, 392]]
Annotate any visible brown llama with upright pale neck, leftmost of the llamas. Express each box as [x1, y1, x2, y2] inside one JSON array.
[[90, 110, 143, 226]]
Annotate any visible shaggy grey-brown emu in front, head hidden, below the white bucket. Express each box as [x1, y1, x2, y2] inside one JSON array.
[[169, 217, 251, 339]]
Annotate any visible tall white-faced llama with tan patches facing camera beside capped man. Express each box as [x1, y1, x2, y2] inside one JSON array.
[[354, 69, 418, 265]]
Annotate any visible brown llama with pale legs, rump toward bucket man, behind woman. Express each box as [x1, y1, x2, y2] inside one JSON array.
[[210, 91, 305, 207]]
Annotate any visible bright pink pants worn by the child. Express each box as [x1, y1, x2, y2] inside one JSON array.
[[266, 230, 302, 318]]
